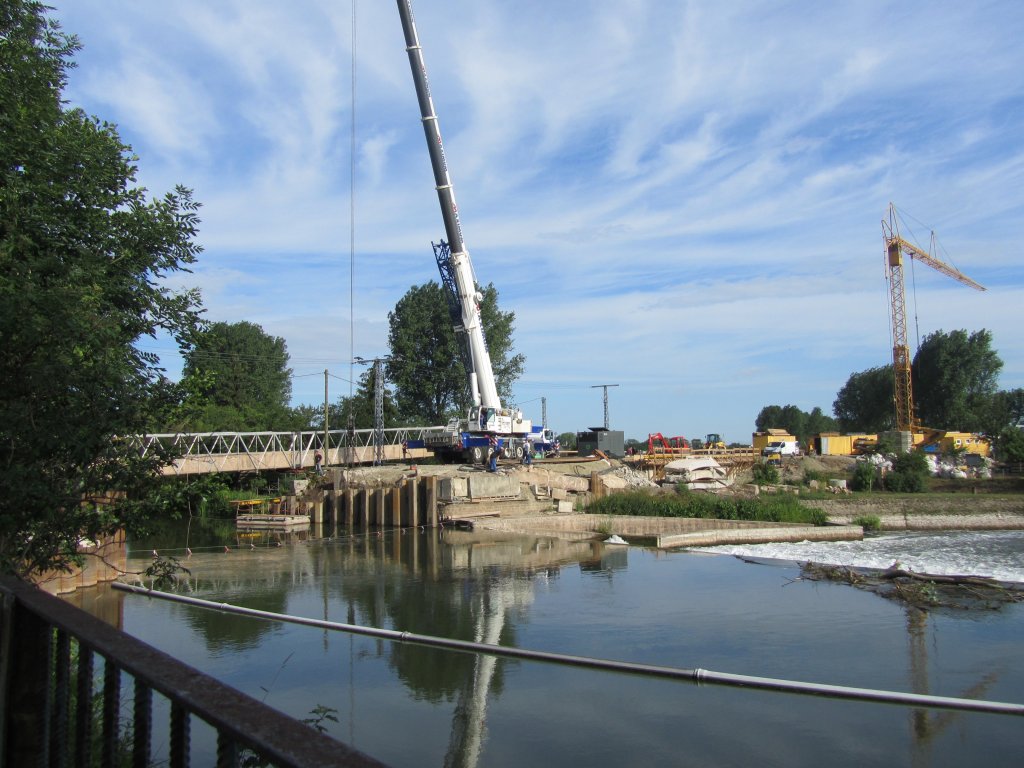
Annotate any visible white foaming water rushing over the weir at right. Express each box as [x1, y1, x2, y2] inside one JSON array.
[[700, 530, 1024, 583]]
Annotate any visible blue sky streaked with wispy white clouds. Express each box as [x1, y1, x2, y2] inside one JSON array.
[[50, 0, 1024, 442]]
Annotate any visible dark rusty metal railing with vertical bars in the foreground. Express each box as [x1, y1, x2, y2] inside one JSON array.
[[0, 578, 382, 768]]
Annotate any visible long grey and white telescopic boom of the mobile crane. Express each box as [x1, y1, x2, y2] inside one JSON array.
[[398, 0, 502, 411]]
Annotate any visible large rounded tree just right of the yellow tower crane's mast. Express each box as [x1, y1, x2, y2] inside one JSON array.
[[911, 330, 1002, 432]]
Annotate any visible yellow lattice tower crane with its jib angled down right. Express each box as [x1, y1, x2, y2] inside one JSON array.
[[882, 203, 985, 432]]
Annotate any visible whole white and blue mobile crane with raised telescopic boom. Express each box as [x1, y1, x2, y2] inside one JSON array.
[[398, 0, 543, 463]]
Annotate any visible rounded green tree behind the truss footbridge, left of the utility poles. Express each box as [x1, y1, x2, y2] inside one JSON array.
[[183, 322, 292, 432]]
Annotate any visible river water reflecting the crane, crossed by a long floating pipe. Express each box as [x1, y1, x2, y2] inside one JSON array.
[[75, 525, 1024, 768]]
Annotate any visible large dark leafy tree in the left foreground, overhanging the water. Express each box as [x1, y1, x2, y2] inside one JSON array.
[[0, 0, 200, 574]]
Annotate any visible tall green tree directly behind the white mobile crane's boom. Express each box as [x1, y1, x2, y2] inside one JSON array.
[[387, 282, 525, 424]]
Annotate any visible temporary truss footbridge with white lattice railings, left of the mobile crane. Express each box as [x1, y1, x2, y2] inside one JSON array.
[[128, 427, 440, 475]]
